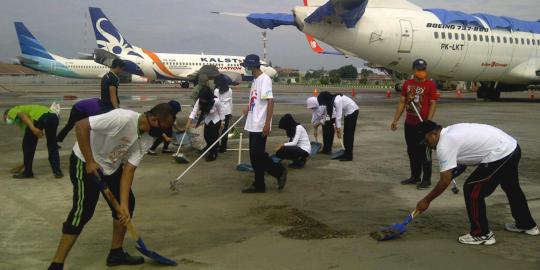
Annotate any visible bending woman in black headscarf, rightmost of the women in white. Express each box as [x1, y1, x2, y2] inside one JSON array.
[[317, 91, 358, 161]]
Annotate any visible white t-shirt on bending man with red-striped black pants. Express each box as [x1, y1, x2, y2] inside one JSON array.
[[437, 124, 517, 172]]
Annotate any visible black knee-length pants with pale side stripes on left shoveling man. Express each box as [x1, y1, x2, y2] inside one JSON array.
[[62, 153, 135, 235]]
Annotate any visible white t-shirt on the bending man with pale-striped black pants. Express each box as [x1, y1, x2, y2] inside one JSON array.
[[73, 109, 154, 175]]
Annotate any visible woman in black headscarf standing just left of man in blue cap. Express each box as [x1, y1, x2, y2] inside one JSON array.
[[214, 74, 233, 153]]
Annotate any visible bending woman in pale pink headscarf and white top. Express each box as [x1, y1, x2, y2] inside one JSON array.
[[306, 97, 336, 155]]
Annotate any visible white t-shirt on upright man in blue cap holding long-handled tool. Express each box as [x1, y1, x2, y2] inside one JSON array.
[[244, 73, 274, 132]]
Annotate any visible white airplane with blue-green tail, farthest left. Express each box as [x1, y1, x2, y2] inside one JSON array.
[[14, 22, 148, 82]]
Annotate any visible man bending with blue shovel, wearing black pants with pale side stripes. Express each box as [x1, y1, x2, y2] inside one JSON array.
[[49, 103, 173, 270]]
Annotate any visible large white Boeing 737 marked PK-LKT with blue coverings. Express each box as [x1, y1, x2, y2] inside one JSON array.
[[219, 0, 540, 99]]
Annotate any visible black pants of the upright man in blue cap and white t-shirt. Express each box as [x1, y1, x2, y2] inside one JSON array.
[[249, 132, 284, 189]]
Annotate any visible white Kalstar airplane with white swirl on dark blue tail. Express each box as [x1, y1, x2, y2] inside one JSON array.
[[89, 7, 277, 88]]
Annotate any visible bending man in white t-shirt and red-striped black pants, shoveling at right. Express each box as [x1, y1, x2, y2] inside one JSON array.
[[416, 120, 540, 245]]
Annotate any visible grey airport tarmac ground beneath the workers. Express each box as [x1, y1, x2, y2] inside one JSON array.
[[0, 85, 540, 270]]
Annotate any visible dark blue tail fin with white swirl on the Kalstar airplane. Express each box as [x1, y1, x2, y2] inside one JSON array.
[[88, 7, 133, 55]]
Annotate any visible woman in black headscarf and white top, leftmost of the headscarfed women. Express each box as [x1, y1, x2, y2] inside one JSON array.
[[186, 86, 225, 161]]
